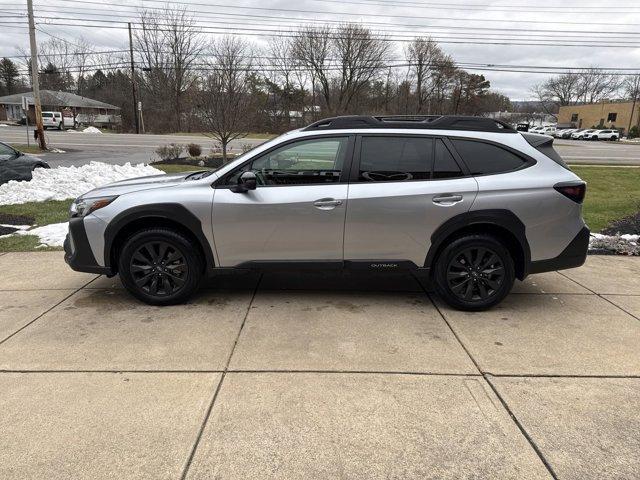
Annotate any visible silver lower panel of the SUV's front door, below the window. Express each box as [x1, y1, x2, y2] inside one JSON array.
[[213, 184, 348, 267]]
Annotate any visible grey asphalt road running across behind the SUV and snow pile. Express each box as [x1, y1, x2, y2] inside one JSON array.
[[0, 127, 640, 166]]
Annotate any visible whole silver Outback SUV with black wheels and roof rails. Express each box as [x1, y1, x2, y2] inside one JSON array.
[[65, 116, 589, 310]]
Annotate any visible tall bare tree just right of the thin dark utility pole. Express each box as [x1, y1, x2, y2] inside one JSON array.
[[135, 7, 206, 131]]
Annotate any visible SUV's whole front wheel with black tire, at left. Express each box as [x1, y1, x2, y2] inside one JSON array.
[[118, 228, 204, 305]]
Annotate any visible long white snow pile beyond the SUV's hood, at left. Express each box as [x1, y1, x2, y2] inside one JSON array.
[[0, 162, 164, 205]]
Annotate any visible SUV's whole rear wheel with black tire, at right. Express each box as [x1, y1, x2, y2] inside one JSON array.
[[434, 234, 515, 311]]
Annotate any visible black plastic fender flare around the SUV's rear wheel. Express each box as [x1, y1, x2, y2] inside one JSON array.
[[424, 209, 531, 278]]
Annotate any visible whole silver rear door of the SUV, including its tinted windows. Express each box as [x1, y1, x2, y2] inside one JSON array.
[[344, 134, 478, 266]]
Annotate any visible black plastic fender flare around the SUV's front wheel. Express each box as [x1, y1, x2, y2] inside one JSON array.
[[104, 203, 215, 271]]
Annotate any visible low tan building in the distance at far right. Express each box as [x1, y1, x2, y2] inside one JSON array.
[[558, 102, 640, 133]]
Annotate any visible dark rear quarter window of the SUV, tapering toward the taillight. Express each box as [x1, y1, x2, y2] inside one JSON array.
[[451, 139, 527, 175]]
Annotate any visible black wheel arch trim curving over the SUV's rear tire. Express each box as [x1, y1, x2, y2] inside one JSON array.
[[424, 209, 531, 280]]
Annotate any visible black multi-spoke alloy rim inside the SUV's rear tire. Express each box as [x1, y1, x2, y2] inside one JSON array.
[[447, 247, 505, 301]]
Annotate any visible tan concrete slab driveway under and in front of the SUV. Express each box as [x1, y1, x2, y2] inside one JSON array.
[[0, 252, 640, 479]]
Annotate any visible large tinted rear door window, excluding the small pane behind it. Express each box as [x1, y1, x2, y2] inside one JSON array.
[[358, 136, 434, 182]]
